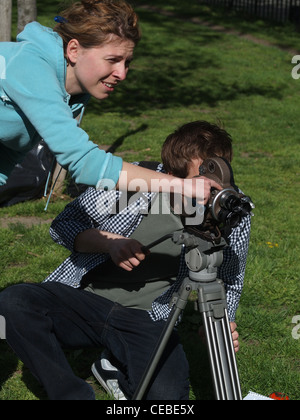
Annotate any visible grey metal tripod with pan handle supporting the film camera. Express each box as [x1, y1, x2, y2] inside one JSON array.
[[133, 231, 242, 401]]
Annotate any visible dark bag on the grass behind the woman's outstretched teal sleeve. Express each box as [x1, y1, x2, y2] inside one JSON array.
[[0, 140, 55, 207]]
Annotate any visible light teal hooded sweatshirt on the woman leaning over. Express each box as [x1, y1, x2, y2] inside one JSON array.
[[0, 22, 123, 188]]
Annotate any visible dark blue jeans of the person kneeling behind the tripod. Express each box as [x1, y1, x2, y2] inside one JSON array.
[[0, 283, 189, 400]]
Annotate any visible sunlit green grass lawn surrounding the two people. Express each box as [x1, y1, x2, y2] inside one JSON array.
[[0, 0, 300, 400]]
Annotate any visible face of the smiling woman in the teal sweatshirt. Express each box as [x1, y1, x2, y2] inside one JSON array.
[[66, 35, 135, 100]]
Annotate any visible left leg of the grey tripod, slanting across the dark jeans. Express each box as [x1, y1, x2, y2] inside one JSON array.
[[133, 282, 192, 401]]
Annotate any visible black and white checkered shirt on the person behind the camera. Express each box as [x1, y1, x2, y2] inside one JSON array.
[[45, 165, 251, 321]]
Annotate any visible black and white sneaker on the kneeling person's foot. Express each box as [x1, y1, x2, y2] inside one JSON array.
[[92, 350, 127, 401]]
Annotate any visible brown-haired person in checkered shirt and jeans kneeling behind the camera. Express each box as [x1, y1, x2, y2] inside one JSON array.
[[0, 121, 250, 400]]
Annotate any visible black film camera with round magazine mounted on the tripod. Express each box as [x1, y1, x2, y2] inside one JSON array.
[[186, 157, 255, 243]]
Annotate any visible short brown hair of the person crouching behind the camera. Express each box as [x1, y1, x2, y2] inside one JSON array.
[[161, 121, 232, 178]]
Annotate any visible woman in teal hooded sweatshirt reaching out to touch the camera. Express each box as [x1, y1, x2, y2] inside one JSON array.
[[0, 0, 215, 201]]
